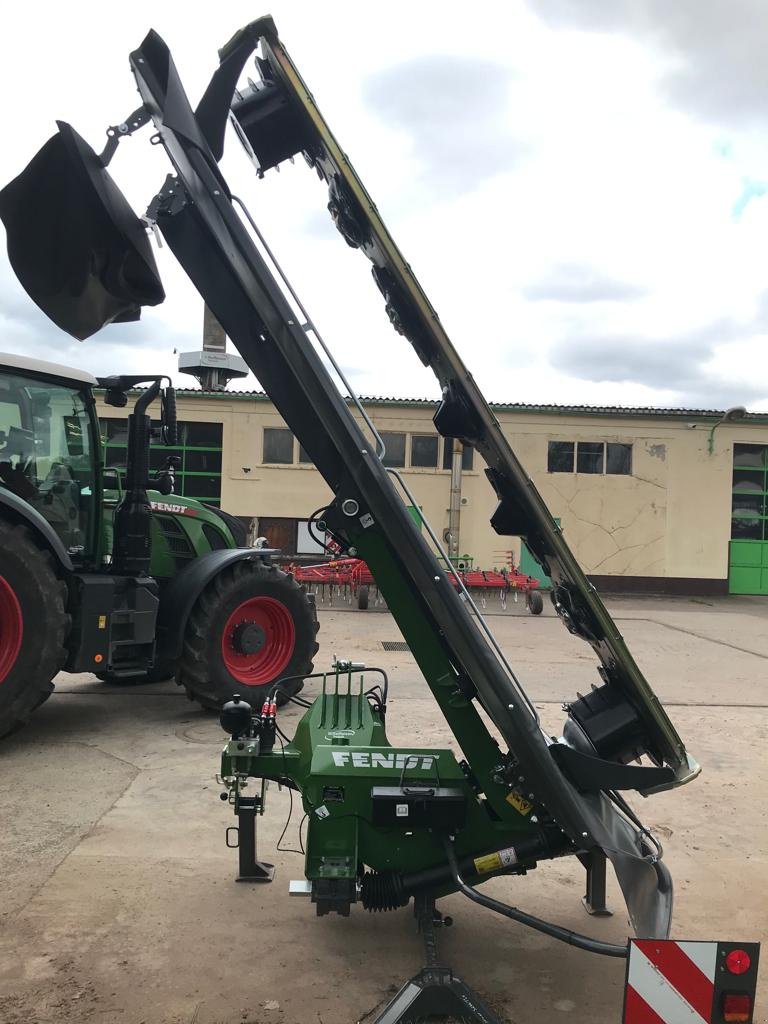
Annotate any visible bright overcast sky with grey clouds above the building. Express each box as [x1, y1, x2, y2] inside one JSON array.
[[0, 0, 768, 411]]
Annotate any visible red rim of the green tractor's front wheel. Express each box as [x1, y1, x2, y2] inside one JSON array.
[[221, 597, 296, 686]]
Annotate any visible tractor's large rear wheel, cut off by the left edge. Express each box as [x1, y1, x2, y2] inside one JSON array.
[[0, 521, 70, 736]]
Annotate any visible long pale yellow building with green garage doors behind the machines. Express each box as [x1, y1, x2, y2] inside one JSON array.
[[99, 390, 768, 594]]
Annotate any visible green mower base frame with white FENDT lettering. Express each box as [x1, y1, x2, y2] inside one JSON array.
[[221, 673, 565, 912]]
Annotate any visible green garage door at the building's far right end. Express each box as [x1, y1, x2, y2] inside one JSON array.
[[728, 444, 768, 594]]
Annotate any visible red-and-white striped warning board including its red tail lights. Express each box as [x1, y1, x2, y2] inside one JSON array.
[[623, 939, 760, 1024]]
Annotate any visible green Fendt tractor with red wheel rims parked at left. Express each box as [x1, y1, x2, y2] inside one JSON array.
[[0, 355, 317, 736]]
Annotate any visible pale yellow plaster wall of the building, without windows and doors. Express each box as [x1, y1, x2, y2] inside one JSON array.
[[99, 392, 768, 591]]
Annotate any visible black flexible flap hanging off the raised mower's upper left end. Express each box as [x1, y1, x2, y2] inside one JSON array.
[[0, 121, 165, 341]]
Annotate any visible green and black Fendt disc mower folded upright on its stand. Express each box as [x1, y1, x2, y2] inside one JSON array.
[[0, 17, 754, 1024]]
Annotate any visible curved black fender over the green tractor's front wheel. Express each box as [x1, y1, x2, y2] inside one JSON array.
[[157, 548, 280, 663]]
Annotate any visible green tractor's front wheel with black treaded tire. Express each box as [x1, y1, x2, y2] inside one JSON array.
[[176, 561, 318, 708]]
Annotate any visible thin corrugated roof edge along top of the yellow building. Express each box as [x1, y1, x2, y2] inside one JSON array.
[[97, 388, 768, 423]]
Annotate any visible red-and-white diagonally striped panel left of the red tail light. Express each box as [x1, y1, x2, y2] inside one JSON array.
[[624, 939, 718, 1024]]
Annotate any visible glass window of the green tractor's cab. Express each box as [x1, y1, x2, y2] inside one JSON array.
[[0, 373, 95, 562]]
